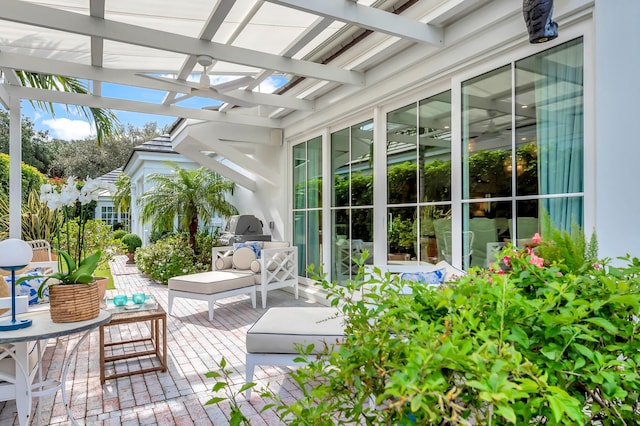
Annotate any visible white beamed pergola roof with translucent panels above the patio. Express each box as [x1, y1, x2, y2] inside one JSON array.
[[0, 0, 500, 238]]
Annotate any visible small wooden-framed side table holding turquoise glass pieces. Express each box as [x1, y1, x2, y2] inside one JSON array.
[[100, 305, 167, 383]]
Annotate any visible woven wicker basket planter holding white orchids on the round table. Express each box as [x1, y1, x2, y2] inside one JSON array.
[[49, 281, 100, 322]]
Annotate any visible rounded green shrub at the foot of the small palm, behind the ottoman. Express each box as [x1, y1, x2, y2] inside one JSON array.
[[135, 234, 204, 284]]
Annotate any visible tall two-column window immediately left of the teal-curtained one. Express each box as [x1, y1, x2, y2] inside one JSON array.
[[387, 91, 451, 263]]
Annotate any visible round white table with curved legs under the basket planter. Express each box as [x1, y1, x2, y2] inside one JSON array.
[[0, 310, 111, 425]]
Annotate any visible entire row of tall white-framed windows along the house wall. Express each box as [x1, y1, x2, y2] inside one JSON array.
[[293, 39, 584, 274]]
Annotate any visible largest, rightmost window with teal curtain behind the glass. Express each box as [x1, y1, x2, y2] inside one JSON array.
[[462, 39, 584, 266]]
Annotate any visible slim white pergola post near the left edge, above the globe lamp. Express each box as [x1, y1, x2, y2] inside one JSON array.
[[9, 96, 22, 238]]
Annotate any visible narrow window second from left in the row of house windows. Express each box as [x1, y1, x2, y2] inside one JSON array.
[[330, 120, 374, 282]]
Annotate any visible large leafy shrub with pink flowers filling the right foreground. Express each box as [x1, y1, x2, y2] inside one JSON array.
[[211, 240, 640, 425]]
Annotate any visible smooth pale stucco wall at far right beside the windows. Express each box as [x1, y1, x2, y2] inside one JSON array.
[[594, 0, 640, 257]]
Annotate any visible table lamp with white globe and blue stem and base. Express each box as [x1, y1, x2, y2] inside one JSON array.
[[0, 238, 33, 331]]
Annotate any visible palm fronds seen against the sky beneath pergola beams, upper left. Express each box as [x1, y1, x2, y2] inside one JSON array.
[[16, 70, 122, 145]]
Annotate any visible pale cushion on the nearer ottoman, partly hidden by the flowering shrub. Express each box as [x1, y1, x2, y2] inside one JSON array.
[[247, 307, 344, 354]]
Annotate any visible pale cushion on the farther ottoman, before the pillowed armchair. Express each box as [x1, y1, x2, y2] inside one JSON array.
[[169, 270, 255, 294]]
